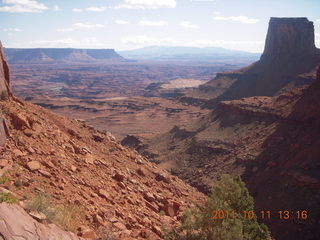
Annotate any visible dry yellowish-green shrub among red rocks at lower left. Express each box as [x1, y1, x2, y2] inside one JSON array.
[[27, 193, 81, 231]]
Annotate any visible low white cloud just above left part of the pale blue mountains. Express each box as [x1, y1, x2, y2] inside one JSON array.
[[121, 36, 176, 46]]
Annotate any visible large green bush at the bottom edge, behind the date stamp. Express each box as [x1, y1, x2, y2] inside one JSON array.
[[165, 175, 270, 240]]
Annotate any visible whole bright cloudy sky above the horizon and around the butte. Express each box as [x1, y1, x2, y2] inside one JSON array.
[[0, 0, 320, 52]]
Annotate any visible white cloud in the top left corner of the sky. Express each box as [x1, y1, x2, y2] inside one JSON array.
[[0, 0, 48, 13]]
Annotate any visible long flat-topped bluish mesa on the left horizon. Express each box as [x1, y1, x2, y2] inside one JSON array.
[[5, 48, 125, 64]]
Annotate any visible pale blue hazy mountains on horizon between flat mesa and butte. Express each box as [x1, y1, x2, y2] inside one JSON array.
[[119, 46, 260, 60]]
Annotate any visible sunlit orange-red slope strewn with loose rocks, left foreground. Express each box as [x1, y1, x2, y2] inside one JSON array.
[[0, 42, 204, 239]]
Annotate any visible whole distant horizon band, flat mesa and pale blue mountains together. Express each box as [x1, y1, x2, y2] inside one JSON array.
[[5, 46, 260, 64]]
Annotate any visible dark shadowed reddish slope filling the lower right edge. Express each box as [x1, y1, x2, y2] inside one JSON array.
[[244, 68, 320, 239]]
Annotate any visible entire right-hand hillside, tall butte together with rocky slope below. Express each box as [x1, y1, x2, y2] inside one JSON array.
[[130, 19, 320, 239]]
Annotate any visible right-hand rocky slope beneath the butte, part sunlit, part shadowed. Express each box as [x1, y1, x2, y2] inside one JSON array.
[[141, 68, 320, 239]]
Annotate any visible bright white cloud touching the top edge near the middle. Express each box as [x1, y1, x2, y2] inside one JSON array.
[[116, 0, 177, 9]]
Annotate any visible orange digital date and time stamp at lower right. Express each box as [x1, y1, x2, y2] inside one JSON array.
[[211, 209, 308, 220]]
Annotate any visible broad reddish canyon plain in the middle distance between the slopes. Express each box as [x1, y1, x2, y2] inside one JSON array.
[[9, 54, 243, 139]]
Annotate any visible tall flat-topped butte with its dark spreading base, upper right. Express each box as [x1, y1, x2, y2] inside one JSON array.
[[192, 18, 320, 108]]
